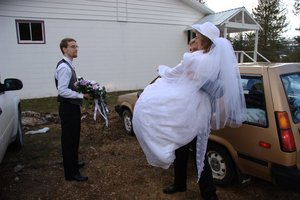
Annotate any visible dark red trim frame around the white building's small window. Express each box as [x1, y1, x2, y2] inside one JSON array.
[[15, 19, 46, 44]]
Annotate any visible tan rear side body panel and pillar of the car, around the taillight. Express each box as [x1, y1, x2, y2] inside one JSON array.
[[210, 64, 300, 184]]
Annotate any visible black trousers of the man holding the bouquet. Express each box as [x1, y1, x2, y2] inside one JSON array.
[[59, 102, 81, 179]]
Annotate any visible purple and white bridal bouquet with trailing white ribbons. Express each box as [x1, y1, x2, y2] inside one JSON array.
[[75, 77, 109, 126]]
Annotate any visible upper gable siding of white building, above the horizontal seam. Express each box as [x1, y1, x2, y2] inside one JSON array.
[[0, 0, 201, 25]]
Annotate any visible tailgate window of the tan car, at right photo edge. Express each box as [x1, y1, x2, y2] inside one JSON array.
[[281, 73, 300, 123]]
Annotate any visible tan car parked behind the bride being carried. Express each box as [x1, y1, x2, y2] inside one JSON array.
[[115, 63, 300, 190]]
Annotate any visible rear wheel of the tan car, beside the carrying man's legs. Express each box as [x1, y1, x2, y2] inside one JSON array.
[[206, 143, 235, 186]]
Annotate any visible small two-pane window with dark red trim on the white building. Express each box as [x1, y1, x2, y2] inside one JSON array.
[[16, 20, 46, 44]]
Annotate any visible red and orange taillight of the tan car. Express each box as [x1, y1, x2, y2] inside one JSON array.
[[275, 112, 296, 152]]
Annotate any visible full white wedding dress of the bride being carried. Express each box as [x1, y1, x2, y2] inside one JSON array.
[[132, 38, 243, 177]]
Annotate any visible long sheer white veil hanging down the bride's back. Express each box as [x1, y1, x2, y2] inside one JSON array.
[[211, 38, 246, 129]]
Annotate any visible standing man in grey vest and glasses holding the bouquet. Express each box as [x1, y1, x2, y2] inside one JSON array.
[[55, 38, 91, 181]]
